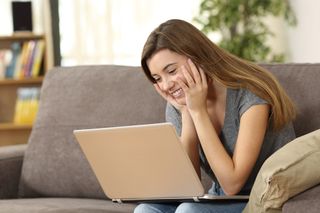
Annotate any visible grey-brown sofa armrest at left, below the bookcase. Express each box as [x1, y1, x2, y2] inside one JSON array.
[[0, 144, 27, 199]]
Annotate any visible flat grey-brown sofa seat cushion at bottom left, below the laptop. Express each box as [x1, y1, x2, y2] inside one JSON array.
[[0, 198, 136, 213]]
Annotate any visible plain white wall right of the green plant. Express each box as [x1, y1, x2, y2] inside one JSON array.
[[286, 0, 320, 63]]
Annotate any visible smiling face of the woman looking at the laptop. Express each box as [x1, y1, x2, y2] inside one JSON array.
[[147, 49, 187, 105]]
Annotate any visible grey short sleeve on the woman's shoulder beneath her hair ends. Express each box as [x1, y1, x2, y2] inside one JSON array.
[[239, 90, 268, 117]]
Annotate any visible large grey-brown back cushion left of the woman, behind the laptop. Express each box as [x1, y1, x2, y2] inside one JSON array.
[[19, 65, 166, 198]]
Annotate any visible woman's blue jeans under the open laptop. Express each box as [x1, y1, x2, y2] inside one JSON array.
[[134, 184, 247, 213]]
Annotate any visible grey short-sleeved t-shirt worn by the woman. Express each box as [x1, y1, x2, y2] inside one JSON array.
[[166, 89, 295, 194]]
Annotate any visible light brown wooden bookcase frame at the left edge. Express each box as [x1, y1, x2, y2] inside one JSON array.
[[0, 32, 51, 146]]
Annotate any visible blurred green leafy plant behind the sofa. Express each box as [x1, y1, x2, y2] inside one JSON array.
[[195, 0, 297, 62]]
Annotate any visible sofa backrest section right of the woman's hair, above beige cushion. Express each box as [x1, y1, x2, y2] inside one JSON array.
[[262, 63, 320, 137]]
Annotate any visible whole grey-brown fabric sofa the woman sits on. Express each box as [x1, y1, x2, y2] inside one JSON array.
[[0, 64, 320, 213]]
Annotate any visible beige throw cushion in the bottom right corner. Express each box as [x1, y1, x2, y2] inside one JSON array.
[[244, 129, 320, 212]]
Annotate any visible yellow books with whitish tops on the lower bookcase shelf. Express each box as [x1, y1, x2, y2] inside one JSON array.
[[14, 87, 40, 124]]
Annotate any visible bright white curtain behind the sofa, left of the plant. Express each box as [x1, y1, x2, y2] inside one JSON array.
[[59, 0, 200, 66]]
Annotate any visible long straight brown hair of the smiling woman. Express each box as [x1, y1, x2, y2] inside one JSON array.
[[141, 19, 296, 130]]
